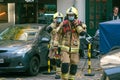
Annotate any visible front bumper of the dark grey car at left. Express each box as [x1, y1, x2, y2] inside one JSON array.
[[0, 56, 29, 72]]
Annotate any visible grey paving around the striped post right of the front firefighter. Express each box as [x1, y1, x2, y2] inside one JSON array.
[[76, 59, 102, 80]]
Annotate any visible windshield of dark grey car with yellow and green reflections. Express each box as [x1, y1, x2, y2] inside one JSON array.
[[0, 26, 38, 41]]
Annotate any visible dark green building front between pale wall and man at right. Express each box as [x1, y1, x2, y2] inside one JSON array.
[[86, 0, 112, 36]]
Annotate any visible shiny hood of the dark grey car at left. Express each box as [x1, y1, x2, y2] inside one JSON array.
[[0, 40, 31, 52]]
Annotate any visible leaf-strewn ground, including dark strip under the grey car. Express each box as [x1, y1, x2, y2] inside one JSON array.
[[0, 59, 102, 80]]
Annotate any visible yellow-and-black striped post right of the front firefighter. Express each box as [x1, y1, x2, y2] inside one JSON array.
[[85, 43, 95, 76]]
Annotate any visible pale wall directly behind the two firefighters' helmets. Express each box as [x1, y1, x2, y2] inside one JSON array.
[[57, 0, 85, 22]]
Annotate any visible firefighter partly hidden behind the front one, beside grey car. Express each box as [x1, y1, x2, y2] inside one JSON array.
[[47, 12, 64, 79]]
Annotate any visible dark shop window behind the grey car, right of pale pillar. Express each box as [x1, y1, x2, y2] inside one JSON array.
[[15, 0, 57, 24]]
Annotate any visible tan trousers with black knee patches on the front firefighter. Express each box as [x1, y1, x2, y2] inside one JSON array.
[[61, 51, 79, 80]]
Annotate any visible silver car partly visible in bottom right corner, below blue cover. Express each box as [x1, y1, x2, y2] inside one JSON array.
[[100, 46, 120, 80]]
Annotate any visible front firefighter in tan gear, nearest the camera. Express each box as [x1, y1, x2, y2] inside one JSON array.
[[57, 7, 86, 80]]
